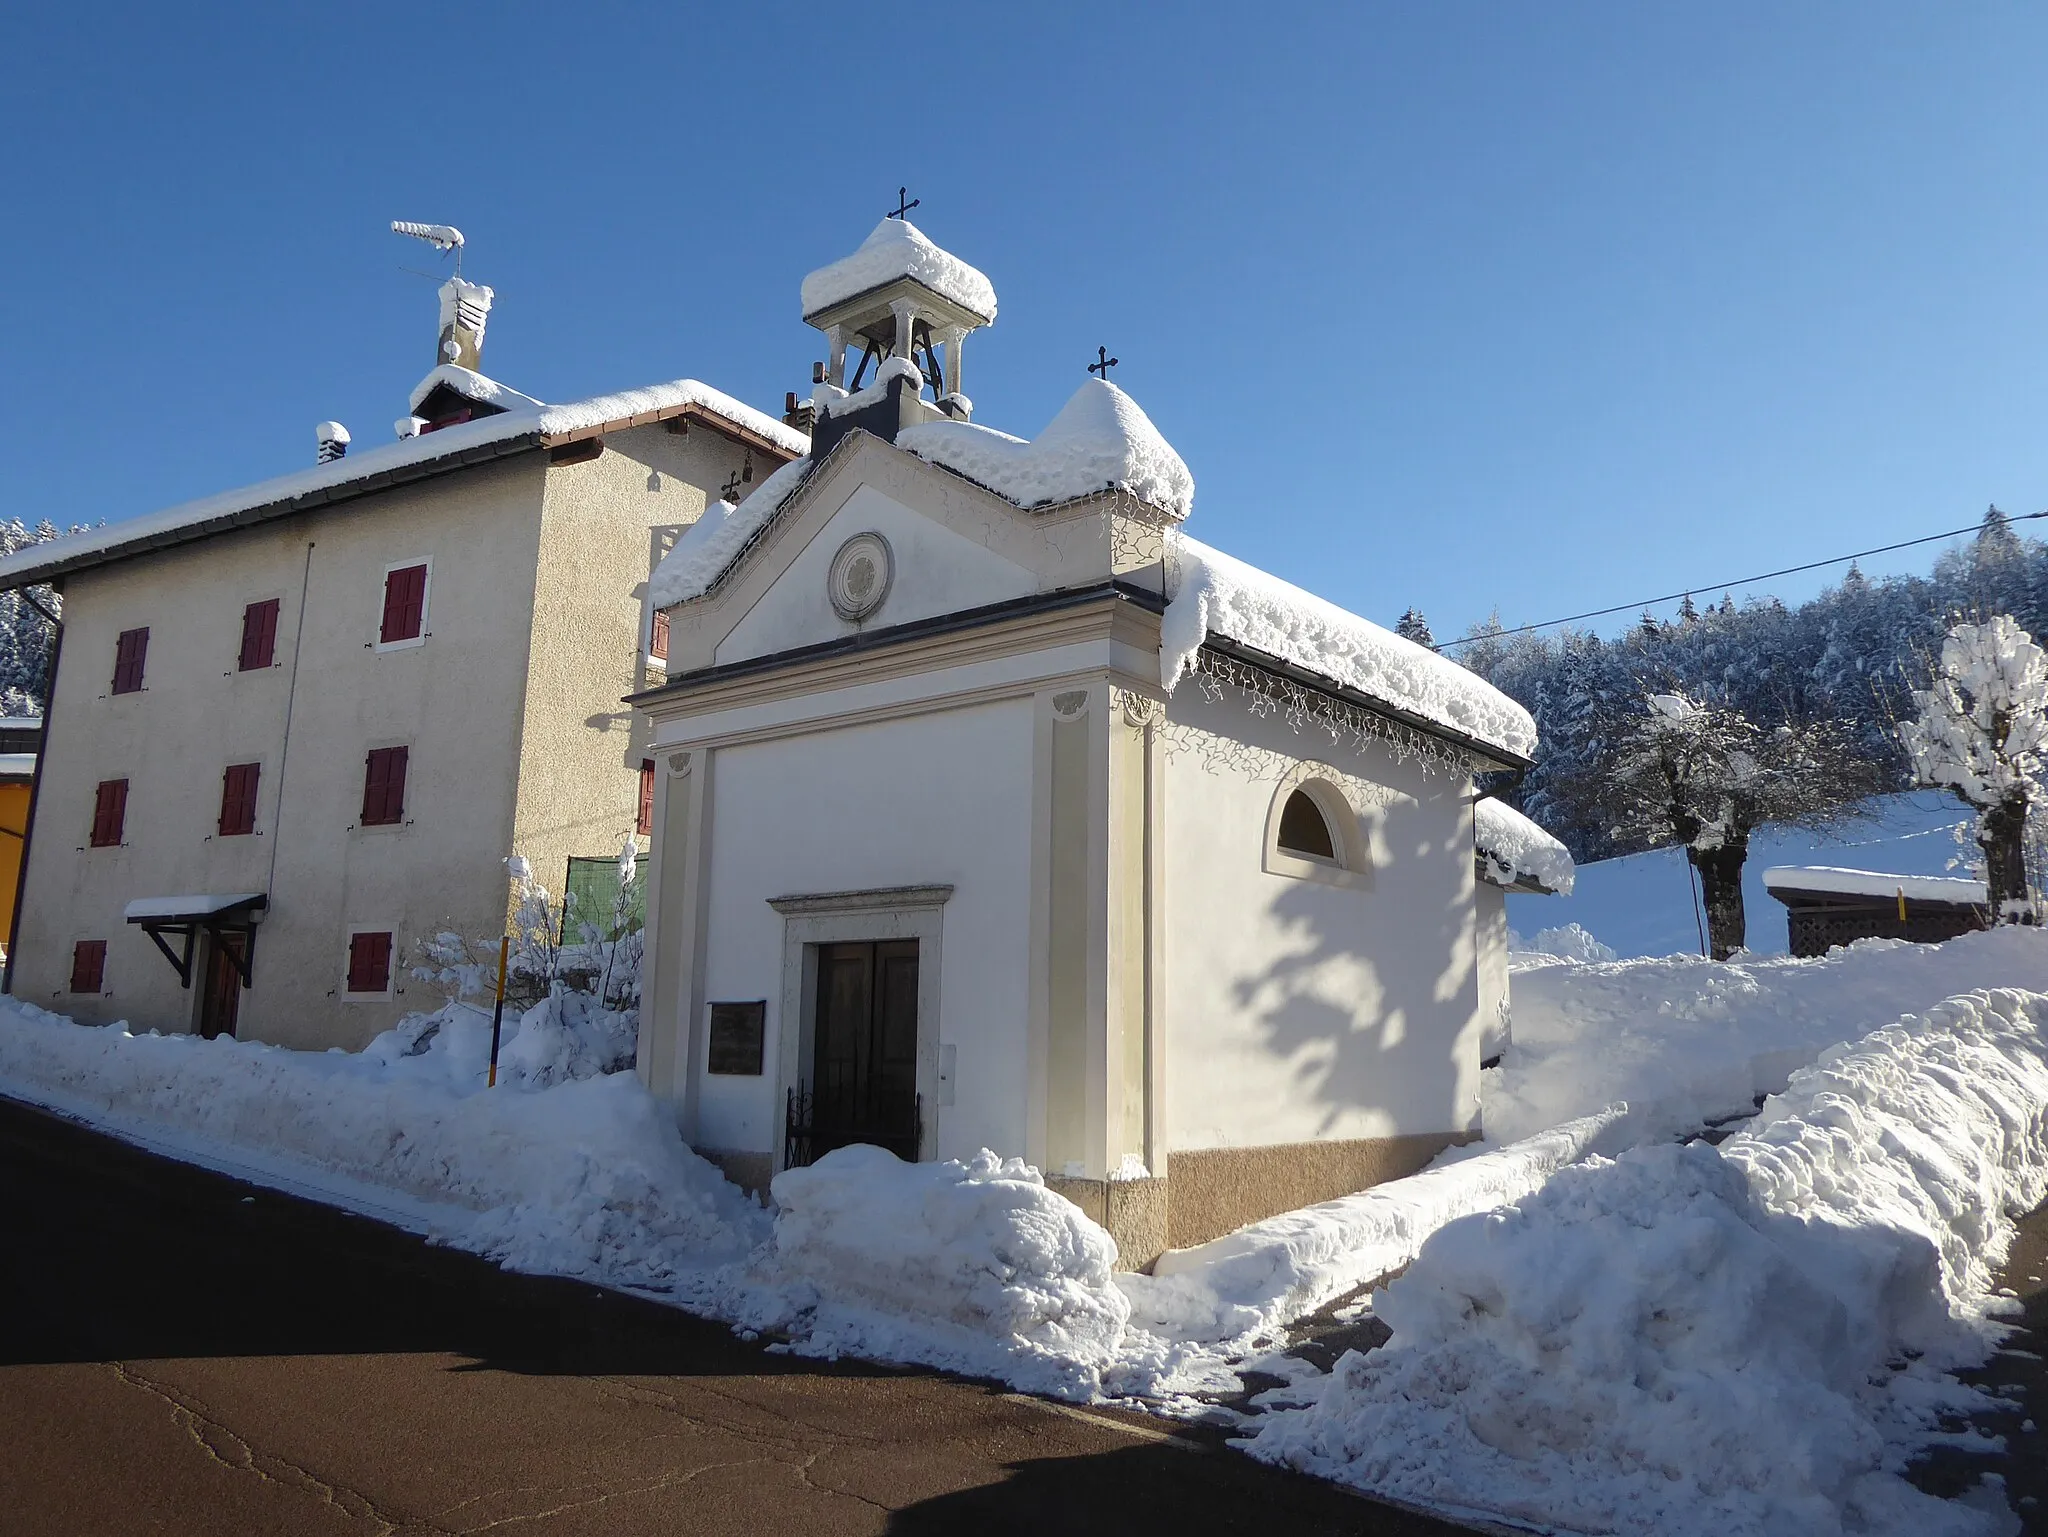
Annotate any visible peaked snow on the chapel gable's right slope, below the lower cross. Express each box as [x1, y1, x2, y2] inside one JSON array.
[[897, 379, 1194, 518]]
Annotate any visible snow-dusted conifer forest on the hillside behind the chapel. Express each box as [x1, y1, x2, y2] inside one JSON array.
[[1458, 508, 2048, 861]]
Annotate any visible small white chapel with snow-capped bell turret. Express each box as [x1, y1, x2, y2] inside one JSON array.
[[633, 217, 1536, 1264]]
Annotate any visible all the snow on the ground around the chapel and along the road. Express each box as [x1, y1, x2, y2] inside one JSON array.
[[0, 930, 2048, 1537]]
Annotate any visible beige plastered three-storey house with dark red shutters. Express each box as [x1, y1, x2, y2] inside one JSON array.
[[0, 279, 807, 1049]]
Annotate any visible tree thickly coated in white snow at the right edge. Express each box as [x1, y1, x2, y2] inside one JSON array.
[[1898, 615, 2048, 922]]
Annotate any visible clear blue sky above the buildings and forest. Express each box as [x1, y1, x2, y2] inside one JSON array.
[[0, 4, 2048, 635]]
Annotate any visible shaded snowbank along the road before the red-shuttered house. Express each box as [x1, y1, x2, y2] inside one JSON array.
[[0, 1000, 768, 1295]]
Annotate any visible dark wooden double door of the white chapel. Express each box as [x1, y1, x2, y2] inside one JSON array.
[[809, 939, 920, 1162]]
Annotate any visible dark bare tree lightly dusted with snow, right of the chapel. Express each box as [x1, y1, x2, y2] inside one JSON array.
[[1595, 693, 1884, 961]]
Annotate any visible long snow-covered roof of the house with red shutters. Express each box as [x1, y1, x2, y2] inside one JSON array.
[[0, 375, 811, 590]]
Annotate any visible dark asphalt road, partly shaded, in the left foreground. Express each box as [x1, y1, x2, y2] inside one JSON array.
[[0, 1100, 1460, 1537]]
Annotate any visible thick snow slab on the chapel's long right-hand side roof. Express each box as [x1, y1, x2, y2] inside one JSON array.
[[1159, 533, 1536, 758]]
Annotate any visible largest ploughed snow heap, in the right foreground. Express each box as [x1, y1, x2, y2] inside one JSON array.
[[1247, 992, 2048, 1537]]
